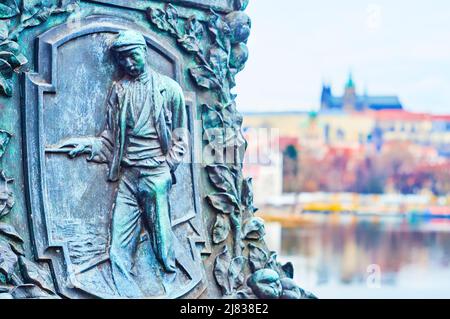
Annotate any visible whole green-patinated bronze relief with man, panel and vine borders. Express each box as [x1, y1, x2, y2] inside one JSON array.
[[0, 0, 313, 299]]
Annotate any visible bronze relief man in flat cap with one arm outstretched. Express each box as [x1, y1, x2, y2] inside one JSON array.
[[55, 30, 188, 297]]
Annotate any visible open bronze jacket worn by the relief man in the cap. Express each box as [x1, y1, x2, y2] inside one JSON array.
[[92, 70, 189, 183]]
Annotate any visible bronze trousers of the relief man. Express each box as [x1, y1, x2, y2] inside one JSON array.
[[110, 163, 176, 297]]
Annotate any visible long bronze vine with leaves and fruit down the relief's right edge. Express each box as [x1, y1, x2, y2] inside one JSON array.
[[147, 1, 314, 299]]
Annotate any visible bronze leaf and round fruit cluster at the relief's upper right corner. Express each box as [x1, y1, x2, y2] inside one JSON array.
[[147, 4, 251, 105]]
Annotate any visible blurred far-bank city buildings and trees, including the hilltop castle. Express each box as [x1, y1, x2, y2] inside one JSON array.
[[244, 75, 450, 213]]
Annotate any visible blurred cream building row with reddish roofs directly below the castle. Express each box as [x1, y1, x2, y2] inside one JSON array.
[[244, 109, 450, 158]]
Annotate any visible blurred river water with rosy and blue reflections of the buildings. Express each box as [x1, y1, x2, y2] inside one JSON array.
[[280, 215, 450, 298]]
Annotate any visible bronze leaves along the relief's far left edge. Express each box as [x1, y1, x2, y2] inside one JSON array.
[[0, 0, 77, 299]]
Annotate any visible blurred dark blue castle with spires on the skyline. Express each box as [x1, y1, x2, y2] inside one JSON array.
[[321, 74, 403, 112]]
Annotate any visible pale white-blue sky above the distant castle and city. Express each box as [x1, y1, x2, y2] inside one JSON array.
[[235, 0, 450, 114]]
